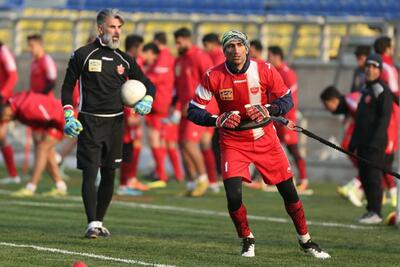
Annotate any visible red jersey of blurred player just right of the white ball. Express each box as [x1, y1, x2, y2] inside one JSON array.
[[145, 48, 175, 115]]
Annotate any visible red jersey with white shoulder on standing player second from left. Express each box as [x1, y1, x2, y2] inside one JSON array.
[[30, 54, 57, 94]]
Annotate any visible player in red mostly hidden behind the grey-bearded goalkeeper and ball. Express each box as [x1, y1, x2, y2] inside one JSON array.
[[117, 34, 148, 196]]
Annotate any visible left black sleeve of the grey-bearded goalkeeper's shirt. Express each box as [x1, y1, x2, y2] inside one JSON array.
[[61, 51, 83, 106]]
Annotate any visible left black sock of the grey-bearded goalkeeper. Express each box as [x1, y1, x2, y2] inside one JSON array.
[[82, 166, 98, 223]]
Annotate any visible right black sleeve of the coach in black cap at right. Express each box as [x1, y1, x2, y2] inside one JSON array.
[[370, 89, 393, 149]]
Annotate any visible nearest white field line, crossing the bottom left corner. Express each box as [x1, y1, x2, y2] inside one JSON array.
[[0, 242, 175, 267]]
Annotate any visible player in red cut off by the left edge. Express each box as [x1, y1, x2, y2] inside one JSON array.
[[0, 42, 21, 184]]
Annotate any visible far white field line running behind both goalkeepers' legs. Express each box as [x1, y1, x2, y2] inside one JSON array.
[[0, 190, 378, 230]]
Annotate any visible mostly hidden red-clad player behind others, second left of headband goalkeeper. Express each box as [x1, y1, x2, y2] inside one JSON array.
[[153, 32, 184, 184]]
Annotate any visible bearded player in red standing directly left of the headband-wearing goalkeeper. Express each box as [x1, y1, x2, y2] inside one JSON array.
[[174, 28, 216, 196]]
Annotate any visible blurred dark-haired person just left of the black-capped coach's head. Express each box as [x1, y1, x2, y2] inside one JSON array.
[[351, 45, 371, 92]]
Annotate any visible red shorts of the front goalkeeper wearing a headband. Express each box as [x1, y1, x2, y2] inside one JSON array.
[[221, 135, 293, 185]]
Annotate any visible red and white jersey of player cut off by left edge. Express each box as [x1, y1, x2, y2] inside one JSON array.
[[0, 44, 18, 101]]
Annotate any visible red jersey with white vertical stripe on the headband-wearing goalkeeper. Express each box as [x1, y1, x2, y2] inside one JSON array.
[[192, 60, 290, 141]]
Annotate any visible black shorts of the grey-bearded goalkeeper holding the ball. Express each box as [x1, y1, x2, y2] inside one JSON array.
[[76, 113, 124, 169]]
